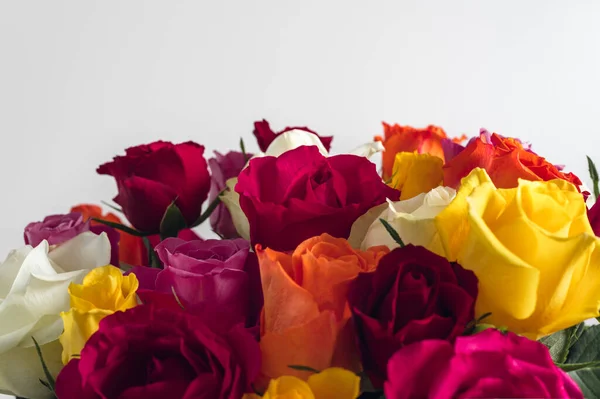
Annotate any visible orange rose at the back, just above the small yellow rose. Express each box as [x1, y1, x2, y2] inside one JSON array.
[[375, 122, 467, 180]]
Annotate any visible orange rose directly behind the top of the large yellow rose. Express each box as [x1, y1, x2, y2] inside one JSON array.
[[444, 132, 581, 188]]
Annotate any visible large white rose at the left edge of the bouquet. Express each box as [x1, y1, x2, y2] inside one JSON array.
[[0, 232, 110, 399]]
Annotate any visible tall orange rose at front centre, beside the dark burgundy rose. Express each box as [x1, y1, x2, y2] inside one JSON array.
[[256, 234, 389, 383]]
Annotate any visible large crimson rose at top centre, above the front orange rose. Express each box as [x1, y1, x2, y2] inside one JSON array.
[[235, 146, 400, 251]]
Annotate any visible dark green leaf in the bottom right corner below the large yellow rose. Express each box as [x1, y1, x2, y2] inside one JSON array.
[[566, 324, 600, 398]]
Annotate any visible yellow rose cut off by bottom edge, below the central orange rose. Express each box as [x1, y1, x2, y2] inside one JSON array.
[[243, 367, 360, 399]]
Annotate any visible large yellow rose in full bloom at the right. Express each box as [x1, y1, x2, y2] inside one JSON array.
[[436, 169, 600, 339]]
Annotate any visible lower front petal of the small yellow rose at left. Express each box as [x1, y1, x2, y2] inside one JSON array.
[[59, 309, 113, 364]]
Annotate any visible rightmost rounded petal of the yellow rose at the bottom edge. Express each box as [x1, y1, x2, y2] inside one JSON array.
[[307, 367, 360, 399]]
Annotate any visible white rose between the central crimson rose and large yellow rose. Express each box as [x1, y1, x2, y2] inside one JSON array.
[[354, 187, 456, 255]]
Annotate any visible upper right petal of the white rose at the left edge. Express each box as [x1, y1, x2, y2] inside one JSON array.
[[50, 231, 110, 272]]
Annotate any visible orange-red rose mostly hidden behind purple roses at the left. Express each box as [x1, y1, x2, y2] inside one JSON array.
[[71, 204, 147, 266]]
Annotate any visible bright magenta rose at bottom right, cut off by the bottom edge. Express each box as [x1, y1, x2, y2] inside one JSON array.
[[385, 329, 583, 399]]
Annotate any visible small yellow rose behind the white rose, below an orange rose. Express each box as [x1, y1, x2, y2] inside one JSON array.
[[389, 152, 444, 200]]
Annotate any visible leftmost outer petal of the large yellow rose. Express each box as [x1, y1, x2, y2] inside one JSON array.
[[434, 168, 493, 262]]
